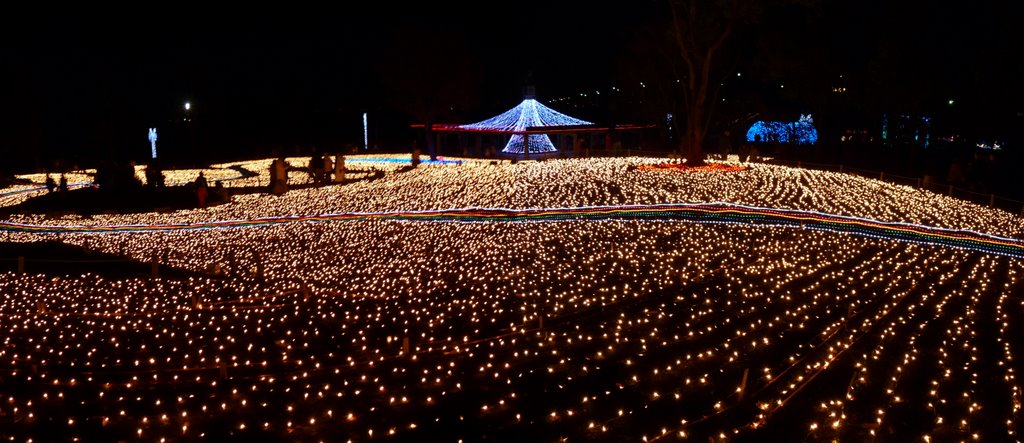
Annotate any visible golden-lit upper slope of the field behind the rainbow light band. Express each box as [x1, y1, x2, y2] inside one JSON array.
[[6, 154, 1024, 239]]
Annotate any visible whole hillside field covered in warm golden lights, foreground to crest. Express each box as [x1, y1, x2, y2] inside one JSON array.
[[0, 156, 1024, 441]]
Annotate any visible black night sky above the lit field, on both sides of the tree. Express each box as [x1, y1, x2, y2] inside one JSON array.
[[0, 0, 1024, 167]]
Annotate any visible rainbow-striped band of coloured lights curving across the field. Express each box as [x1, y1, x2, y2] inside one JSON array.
[[6, 203, 1024, 258]]
